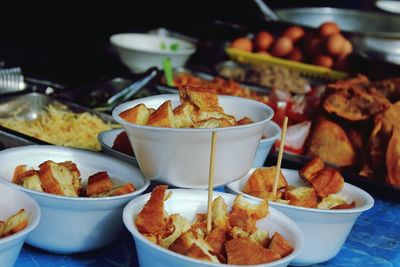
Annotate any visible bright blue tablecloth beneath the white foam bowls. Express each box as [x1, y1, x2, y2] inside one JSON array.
[[14, 191, 400, 267]]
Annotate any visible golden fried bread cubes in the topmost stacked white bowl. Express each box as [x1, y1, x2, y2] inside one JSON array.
[[119, 86, 252, 128]]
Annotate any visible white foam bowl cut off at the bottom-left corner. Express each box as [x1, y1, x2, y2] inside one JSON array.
[[0, 184, 40, 267]]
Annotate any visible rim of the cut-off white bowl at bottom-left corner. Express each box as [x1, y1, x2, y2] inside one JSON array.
[[0, 183, 42, 246]]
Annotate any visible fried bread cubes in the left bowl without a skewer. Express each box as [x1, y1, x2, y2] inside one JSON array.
[[12, 160, 136, 197]]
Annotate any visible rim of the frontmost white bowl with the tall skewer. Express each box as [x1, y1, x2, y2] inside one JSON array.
[[122, 188, 304, 267]]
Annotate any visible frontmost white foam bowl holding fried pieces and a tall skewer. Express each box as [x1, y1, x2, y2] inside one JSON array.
[[123, 189, 303, 267]]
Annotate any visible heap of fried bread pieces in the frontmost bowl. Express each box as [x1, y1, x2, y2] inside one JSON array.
[[131, 185, 294, 265]]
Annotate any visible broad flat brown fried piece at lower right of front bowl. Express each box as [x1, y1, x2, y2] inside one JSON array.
[[225, 238, 281, 265]]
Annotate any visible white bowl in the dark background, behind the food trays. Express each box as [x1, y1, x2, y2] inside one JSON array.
[[110, 33, 196, 72]]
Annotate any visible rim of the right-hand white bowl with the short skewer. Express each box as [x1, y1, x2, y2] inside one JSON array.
[[225, 168, 375, 214]]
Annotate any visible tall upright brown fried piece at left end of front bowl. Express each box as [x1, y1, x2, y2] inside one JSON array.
[[135, 185, 168, 234]]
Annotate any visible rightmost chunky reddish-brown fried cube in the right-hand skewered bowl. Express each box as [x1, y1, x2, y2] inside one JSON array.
[[310, 168, 344, 198]]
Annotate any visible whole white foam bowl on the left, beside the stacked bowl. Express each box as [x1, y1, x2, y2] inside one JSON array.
[[0, 145, 150, 254]]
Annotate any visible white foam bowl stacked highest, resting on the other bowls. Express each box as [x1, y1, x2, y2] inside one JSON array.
[[113, 94, 274, 188]]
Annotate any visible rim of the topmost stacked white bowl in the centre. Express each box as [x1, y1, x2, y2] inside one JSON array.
[[112, 94, 274, 133]]
